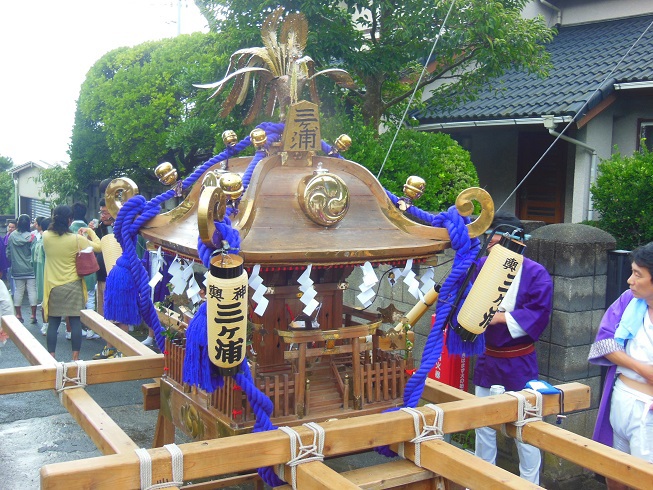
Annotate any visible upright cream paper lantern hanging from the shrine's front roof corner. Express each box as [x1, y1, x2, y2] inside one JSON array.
[[206, 254, 248, 376]]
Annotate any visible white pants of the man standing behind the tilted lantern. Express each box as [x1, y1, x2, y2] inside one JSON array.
[[474, 386, 542, 485]]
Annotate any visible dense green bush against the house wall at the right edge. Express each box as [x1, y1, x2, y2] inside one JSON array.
[[591, 146, 653, 250]]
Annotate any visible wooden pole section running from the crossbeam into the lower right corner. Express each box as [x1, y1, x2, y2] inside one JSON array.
[[506, 422, 653, 490]]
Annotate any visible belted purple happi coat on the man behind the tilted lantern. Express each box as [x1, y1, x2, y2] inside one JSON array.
[[474, 257, 553, 391]]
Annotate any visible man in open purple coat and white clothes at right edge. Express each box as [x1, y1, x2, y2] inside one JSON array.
[[588, 242, 653, 490]]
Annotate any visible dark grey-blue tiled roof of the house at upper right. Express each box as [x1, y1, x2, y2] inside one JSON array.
[[413, 15, 653, 124]]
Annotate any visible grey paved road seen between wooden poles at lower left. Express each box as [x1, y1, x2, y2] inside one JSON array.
[[0, 307, 157, 490]]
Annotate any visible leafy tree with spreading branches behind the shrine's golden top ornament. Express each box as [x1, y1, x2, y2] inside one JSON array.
[[195, 0, 553, 127]]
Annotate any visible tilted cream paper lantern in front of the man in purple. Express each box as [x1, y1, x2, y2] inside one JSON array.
[[455, 236, 526, 342]]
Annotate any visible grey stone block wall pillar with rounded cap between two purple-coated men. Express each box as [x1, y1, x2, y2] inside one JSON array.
[[526, 224, 616, 488]]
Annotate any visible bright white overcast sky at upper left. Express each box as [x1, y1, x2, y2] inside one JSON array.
[[0, 0, 208, 165]]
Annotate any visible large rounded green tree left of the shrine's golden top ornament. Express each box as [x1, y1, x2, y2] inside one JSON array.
[[69, 33, 227, 193]]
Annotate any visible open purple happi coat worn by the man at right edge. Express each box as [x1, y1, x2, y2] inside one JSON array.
[[588, 289, 634, 447]]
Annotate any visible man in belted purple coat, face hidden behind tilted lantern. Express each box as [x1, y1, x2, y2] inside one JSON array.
[[474, 212, 553, 484]]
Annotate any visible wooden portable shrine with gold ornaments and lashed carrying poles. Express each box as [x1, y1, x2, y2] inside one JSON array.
[[0, 10, 653, 490]]
